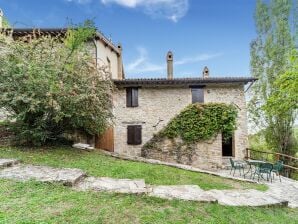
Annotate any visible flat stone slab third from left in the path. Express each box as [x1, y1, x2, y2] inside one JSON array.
[[149, 185, 216, 202]]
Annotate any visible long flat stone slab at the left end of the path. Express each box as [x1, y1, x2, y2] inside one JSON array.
[[0, 165, 86, 186]]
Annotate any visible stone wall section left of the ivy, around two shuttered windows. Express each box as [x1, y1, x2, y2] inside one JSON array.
[[114, 88, 191, 156]]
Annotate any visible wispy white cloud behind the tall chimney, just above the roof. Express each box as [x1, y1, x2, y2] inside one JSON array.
[[125, 47, 223, 73]]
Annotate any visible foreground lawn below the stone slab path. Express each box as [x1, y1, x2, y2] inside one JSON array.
[[0, 180, 298, 224]]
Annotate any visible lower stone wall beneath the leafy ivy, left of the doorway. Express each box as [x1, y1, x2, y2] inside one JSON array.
[[142, 134, 222, 169]]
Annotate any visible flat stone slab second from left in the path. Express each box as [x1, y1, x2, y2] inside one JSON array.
[[76, 177, 147, 194]]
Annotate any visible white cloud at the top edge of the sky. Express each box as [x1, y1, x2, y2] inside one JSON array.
[[101, 0, 188, 22]]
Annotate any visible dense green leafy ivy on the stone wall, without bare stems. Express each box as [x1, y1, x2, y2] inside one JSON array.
[[158, 103, 237, 143]]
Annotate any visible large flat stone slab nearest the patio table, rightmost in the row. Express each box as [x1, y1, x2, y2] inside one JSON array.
[[207, 189, 288, 206]]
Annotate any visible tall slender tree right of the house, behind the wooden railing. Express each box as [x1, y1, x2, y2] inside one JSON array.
[[249, 0, 296, 153]]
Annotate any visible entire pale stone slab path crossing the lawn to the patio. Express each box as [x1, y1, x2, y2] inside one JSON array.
[[0, 159, 298, 208]]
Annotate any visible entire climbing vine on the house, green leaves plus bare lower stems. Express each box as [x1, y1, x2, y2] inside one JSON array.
[[142, 103, 237, 164]]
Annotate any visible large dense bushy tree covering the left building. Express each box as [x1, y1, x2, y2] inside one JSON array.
[[0, 21, 113, 145]]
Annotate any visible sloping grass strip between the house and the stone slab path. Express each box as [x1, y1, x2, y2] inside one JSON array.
[[0, 147, 267, 191]]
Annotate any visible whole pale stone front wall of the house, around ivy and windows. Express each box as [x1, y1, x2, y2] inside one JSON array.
[[114, 84, 247, 168]]
